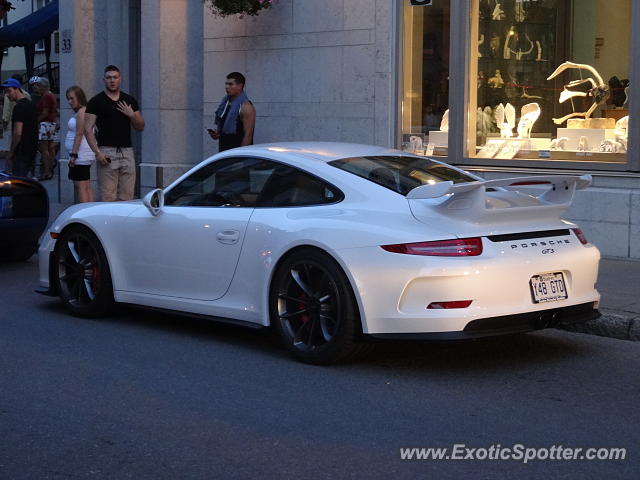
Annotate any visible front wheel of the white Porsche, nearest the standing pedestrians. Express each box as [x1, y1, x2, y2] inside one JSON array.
[[53, 227, 115, 318]]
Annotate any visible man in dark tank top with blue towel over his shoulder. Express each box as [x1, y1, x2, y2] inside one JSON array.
[[208, 72, 256, 152]]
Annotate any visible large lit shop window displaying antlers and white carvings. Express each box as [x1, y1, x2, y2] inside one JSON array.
[[466, 0, 632, 165]]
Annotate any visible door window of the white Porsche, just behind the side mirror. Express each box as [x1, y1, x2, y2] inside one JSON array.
[[165, 158, 277, 207]]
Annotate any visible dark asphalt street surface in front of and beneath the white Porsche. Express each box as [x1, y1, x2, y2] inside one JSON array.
[[0, 258, 640, 480]]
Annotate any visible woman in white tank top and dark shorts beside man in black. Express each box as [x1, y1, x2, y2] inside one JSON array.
[[65, 85, 96, 203]]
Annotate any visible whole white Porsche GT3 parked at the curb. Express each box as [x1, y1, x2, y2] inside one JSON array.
[[39, 143, 600, 363]]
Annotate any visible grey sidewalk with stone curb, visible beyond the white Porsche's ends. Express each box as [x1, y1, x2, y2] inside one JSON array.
[[45, 199, 640, 341]]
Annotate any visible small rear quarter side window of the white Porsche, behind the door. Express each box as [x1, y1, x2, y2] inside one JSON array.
[[256, 164, 342, 207]]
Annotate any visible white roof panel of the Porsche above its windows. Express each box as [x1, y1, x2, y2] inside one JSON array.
[[218, 142, 402, 163]]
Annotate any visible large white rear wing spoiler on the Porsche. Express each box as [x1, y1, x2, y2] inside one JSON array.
[[406, 175, 592, 222]]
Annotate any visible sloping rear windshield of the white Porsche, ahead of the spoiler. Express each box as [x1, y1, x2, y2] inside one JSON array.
[[329, 155, 477, 195]]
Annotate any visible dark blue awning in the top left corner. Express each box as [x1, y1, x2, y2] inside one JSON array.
[[0, 0, 58, 47]]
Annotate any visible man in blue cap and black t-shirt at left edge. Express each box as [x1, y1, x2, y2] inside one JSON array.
[[2, 78, 38, 177]]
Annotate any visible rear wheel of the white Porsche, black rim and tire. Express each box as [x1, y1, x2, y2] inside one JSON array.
[[269, 249, 368, 365]]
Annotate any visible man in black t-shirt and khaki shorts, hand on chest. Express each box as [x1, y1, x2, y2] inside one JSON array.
[[84, 65, 144, 202]]
